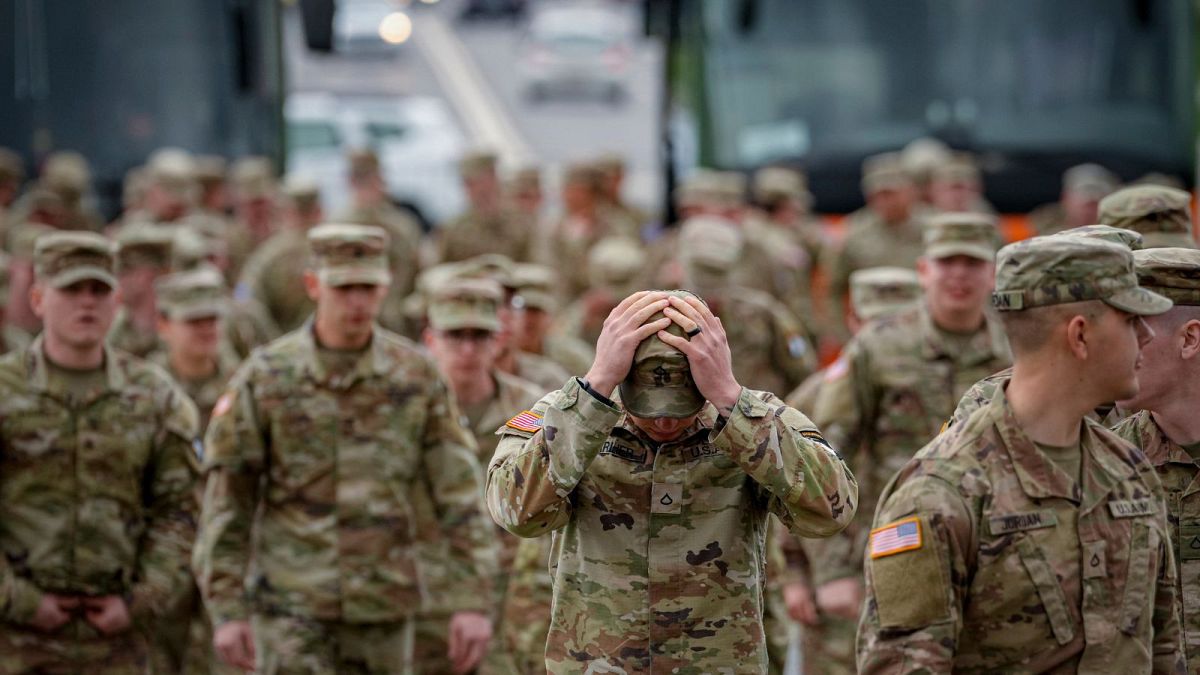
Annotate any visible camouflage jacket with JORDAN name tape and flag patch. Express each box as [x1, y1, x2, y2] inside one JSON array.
[[858, 389, 1183, 675]]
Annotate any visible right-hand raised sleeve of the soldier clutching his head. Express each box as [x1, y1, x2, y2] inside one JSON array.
[[712, 389, 858, 537]]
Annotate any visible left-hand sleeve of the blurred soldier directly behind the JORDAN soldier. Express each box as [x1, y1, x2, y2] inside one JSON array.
[[802, 342, 872, 586]]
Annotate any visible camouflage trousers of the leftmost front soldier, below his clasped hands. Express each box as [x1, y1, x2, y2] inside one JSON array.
[[0, 619, 149, 675]]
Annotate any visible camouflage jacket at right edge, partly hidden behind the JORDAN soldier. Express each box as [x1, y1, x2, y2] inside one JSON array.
[[1112, 411, 1200, 673]]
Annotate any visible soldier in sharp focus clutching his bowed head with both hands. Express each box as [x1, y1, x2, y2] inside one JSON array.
[[487, 292, 858, 674]]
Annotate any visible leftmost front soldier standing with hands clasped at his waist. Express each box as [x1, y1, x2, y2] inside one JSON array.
[[0, 232, 199, 675]]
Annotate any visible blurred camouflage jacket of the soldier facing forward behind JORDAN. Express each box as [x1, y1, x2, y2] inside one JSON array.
[[805, 306, 1012, 586]]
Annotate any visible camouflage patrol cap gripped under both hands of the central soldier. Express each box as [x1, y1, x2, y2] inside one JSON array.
[[619, 291, 704, 419]]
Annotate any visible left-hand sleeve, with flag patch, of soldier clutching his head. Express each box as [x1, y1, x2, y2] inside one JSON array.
[[487, 377, 622, 537]]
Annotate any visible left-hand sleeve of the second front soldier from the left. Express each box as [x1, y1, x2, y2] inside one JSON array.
[[192, 366, 266, 626]]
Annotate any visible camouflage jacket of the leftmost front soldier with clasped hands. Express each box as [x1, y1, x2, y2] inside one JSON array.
[[0, 338, 199, 625]]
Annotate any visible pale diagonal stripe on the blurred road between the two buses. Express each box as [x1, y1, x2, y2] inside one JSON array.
[[413, 13, 534, 165]]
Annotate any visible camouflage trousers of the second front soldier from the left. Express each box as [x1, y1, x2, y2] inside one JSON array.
[[252, 614, 415, 675]]
